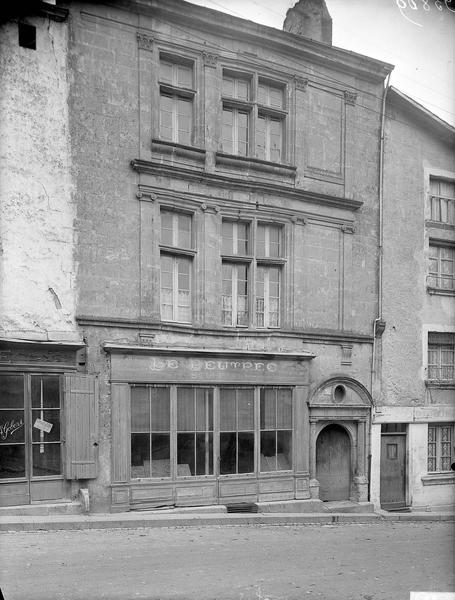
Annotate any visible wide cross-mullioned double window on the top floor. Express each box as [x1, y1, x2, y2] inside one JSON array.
[[222, 71, 287, 162]]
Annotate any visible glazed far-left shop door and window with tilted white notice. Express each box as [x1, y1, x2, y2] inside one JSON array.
[[0, 374, 64, 506]]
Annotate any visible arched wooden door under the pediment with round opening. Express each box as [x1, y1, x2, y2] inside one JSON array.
[[316, 425, 351, 502]]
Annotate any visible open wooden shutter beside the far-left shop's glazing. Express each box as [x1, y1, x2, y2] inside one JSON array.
[[64, 373, 98, 479]]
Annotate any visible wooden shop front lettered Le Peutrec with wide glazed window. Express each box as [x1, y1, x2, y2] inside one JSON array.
[[104, 344, 313, 511]]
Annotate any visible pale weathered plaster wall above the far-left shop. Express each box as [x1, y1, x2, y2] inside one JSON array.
[[0, 17, 77, 340]]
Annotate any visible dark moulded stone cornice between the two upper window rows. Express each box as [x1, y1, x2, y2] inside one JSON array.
[[131, 159, 363, 210]]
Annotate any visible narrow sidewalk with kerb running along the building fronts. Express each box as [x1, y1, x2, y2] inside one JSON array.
[[0, 507, 455, 531]]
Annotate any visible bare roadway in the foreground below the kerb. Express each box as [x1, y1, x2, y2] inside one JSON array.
[[0, 521, 455, 600]]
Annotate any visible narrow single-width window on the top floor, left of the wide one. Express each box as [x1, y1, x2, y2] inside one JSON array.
[[159, 55, 195, 145]]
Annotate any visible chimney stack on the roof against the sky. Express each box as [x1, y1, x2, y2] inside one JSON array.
[[283, 0, 332, 45]]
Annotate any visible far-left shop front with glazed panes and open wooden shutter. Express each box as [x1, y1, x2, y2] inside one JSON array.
[[0, 340, 97, 506]]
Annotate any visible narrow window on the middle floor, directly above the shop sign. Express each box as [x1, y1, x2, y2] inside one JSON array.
[[160, 209, 195, 323]]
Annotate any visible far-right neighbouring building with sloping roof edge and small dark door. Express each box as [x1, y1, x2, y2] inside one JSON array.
[[371, 88, 455, 509]]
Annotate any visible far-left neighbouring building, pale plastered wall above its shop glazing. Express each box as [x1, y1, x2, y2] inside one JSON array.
[[0, 2, 96, 506]]
